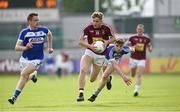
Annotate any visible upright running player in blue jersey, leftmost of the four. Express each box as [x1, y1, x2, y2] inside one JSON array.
[[8, 13, 53, 104]]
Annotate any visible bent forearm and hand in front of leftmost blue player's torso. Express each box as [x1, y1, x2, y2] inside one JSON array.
[[15, 40, 33, 51]]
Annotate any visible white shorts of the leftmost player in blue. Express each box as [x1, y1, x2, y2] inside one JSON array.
[[19, 57, 42, 70]]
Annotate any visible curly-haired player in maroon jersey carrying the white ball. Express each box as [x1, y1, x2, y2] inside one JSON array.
[[77, 12, 115, 101]]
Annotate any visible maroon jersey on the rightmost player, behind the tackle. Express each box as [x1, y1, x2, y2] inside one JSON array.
[[129, 35, 150, 60]]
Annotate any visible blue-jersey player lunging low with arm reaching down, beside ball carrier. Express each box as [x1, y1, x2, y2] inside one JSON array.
[[88, 39, 133, 102]]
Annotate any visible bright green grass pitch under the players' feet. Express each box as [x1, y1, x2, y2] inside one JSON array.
[[0, 74, 180, 112]]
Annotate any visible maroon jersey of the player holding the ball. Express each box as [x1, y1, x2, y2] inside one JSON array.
[[83, 24, 114, 55]]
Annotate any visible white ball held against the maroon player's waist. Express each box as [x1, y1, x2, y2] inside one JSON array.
[[94, 41, 105, 53]]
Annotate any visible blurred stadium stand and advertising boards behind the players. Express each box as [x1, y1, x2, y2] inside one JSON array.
[[0, 0, 180, 76]]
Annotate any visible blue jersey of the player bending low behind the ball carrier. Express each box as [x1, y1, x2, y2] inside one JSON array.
[[106, 45, 130, 61]]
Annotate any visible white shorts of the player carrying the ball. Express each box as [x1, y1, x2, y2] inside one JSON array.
[[85, 49, 105, 66]]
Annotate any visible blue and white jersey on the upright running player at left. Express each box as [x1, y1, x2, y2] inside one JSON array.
[[18, 26, 49, 60]]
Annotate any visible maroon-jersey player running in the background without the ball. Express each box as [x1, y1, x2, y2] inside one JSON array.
[[129, 24, 153, 96]]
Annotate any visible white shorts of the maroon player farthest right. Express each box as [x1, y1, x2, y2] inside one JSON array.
[[129, 58, 146, 68]]
